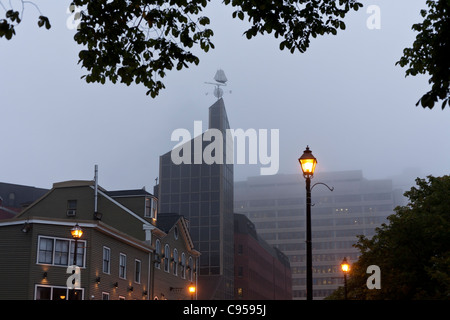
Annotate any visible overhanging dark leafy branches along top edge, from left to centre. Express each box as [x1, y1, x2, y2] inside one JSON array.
[[0, 0, 362, 97]]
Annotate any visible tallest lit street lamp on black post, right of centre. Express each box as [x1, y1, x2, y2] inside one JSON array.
[[298, 146, 317, 300]]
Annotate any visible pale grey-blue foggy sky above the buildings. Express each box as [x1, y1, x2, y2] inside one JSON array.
[[0, 0, 450, 191]]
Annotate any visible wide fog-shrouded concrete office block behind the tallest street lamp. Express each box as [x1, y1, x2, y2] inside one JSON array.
[[235, 171, 402, 299]]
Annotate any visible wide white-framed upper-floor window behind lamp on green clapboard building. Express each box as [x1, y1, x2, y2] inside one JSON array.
[[37, 236, 86, 267]]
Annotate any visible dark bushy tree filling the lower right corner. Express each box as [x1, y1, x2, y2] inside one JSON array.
[[329, 176, 450, 300]]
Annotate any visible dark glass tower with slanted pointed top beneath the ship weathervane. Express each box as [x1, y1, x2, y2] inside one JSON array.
[[158, 98, 234, 299]]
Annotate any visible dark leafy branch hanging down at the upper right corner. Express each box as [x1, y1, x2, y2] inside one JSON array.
[[396, 0, 450, 110]]
